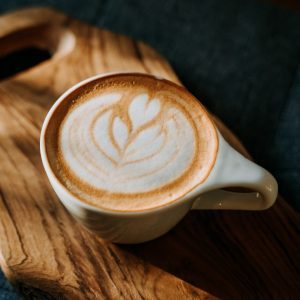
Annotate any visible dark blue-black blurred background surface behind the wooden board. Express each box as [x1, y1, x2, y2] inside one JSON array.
[[0, 0, 300, 300]]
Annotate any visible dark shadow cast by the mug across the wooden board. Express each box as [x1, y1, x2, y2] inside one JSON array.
[[121, 200, 300, 299]]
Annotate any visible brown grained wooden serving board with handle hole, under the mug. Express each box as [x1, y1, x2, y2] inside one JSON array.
[[0, 8, 300, 299]]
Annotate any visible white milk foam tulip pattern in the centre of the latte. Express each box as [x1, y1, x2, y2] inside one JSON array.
[[59, 93, 195, 193]]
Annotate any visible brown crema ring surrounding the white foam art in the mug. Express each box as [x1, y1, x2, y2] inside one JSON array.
[[45, 73, 218, 212]]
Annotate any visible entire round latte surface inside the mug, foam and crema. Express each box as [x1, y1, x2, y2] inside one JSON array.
[[45, 74, 218, 211]]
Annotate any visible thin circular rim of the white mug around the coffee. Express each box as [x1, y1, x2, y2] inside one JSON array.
[[40, 72, 220, 216]]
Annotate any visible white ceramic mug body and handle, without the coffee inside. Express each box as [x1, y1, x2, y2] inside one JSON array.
[[40, 74, 278, 244]]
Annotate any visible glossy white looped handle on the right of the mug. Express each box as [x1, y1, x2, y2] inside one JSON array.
[[192, 132, 278, 210]]
